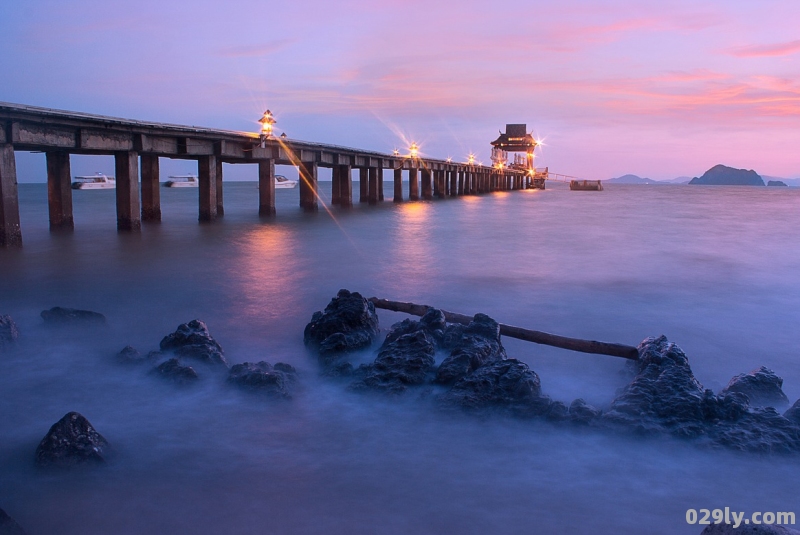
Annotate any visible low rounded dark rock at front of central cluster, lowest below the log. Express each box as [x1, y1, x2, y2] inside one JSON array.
[[441, 359, 549, 415]]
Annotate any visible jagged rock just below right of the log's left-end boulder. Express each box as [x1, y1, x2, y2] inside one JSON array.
[[351, 329, 436, 393]]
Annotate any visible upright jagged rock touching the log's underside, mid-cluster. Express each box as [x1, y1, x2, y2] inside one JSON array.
[[436, 314, 507, 384]]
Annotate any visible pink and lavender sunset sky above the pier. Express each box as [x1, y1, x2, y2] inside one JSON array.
[[0, 0, 800, 181]]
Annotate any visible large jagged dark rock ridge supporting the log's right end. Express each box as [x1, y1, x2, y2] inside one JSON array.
[[601, 336, 800, 452]]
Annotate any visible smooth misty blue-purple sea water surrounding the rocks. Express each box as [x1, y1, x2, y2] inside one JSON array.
[[0, 183, 800, 534]]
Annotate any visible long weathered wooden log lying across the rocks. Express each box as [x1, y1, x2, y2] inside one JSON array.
[[369, 297, 639, 360]]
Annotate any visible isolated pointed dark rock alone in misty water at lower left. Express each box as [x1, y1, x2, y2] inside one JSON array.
[[36, 412, 108, 466]]
